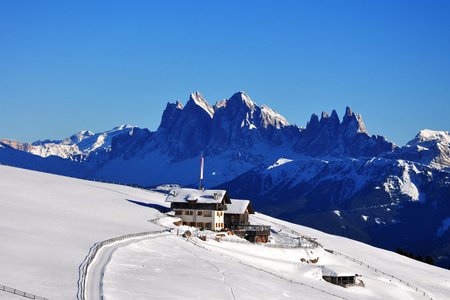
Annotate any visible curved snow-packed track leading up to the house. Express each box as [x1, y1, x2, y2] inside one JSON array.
[[77, 229, 170, 300]]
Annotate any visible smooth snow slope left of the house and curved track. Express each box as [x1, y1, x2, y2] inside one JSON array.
[[0, 166, 165, 299]]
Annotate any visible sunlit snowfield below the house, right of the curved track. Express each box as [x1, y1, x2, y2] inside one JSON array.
[[103, 223, 450, 300]]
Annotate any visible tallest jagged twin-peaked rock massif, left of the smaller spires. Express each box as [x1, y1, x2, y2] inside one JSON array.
[[152, 92, 298, 161]]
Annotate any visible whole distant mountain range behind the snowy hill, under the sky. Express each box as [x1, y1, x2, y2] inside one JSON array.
[[0, 92, 450, 266]]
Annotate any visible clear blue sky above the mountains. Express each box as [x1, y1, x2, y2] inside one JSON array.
[[0, 0, 450, 145]]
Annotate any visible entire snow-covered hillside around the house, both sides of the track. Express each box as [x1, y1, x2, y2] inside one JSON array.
[[0, 166, 450, 300]]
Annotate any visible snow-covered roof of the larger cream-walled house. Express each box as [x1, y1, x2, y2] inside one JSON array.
[[166, 188, 229, 204]]
